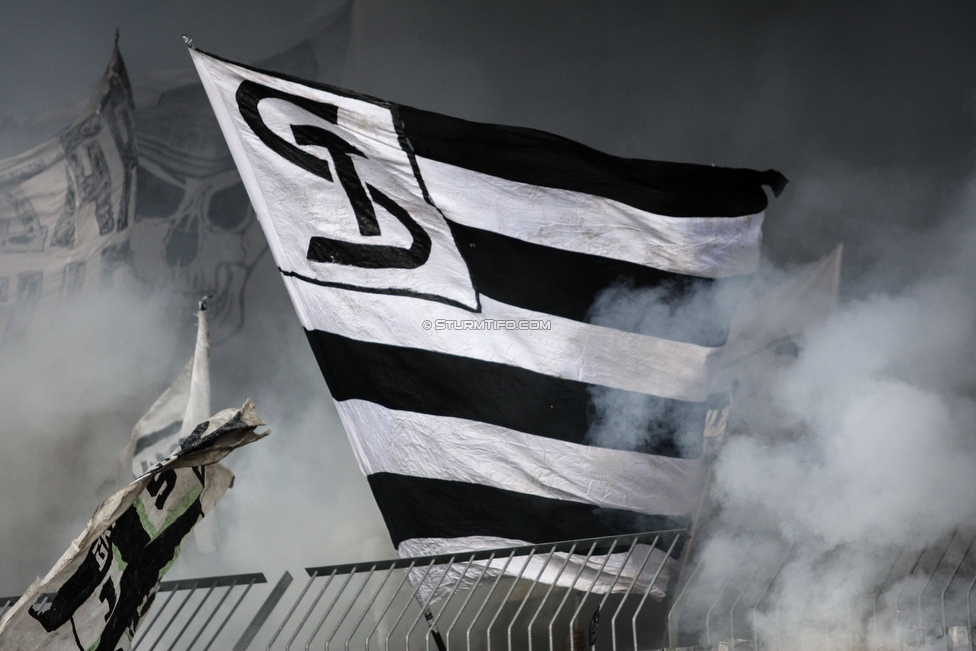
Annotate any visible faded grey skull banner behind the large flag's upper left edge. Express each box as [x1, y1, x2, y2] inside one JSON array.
[[133, 0, 352, 342]]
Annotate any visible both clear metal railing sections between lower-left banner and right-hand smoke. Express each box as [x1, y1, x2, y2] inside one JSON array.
[[0, 531, 688, 651]]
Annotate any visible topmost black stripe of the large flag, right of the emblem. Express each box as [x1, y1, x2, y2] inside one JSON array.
[[396, 105, 787, 217]]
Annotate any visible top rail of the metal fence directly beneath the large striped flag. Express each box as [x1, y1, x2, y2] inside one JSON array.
[[305, 529, 687, 576]]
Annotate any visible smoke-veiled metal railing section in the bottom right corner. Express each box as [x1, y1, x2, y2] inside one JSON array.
[[666, 531, 976, 651]]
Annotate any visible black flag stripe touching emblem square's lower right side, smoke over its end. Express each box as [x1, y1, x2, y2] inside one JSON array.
[[447, 220, 750, 346]]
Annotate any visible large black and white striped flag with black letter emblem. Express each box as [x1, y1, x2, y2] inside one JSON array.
[[191, 48, 786, 596]]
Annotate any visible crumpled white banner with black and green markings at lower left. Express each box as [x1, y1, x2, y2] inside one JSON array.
[[0, 401, 269, 651]]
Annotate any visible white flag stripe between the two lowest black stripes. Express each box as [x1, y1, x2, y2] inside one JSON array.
[[336, 400, 702, 515]]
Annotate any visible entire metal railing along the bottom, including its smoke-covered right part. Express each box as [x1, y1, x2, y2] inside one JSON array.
[[15, 530, 976, 651]]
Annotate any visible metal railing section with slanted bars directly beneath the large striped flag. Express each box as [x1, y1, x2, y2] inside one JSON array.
[[248, 531, 686, 651]]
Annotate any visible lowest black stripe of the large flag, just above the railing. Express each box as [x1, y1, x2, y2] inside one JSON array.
[[366, 472, 690, 554]]
